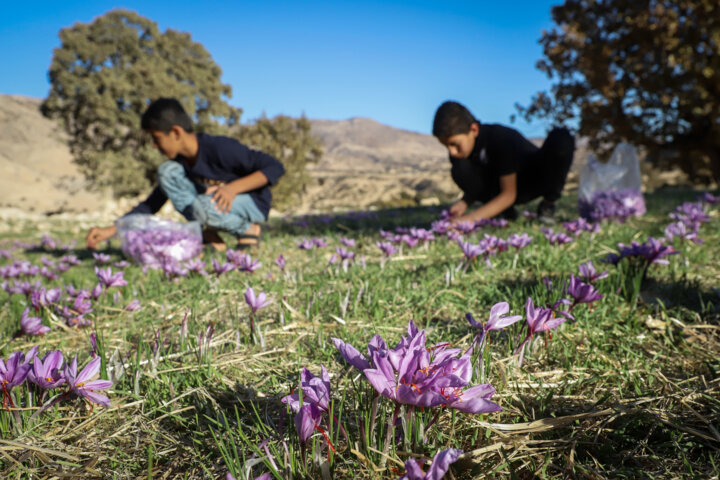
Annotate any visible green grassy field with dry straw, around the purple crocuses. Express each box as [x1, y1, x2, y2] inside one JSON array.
[[0, 190, 720, 479]]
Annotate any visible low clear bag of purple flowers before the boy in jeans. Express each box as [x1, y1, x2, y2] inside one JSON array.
[[115, 214, 202, 268]]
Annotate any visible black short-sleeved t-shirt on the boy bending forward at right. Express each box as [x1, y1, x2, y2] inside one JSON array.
[[450, 124, 539, 203]]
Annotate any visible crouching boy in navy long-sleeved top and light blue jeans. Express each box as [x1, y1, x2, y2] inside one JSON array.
[[86, 98, 285, 250]]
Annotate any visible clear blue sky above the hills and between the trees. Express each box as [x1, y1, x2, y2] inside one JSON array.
[[0, 0, 561, 136]]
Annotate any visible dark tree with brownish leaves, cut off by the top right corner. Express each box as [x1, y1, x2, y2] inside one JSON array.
[[518, 0, 720, 180]]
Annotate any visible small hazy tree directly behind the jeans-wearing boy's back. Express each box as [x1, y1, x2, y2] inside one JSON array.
[[233, 115, 322, 209]]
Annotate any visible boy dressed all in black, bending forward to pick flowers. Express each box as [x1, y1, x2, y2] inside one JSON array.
[[433, 102, 575, 223]]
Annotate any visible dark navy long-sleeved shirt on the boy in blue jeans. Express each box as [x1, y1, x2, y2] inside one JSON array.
[[128, 133, 285, 218]]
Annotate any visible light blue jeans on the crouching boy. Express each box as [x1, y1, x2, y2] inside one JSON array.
[[158, 160, 265, 236]]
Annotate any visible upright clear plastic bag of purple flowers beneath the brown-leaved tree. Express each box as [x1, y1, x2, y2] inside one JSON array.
[[578, 143, 646, 221]]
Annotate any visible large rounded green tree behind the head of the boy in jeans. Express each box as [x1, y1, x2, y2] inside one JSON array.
[[42, 10, 242, 195]]
